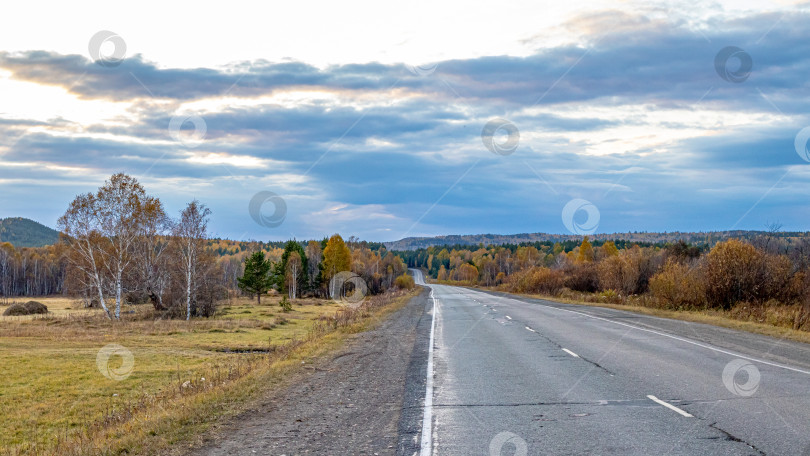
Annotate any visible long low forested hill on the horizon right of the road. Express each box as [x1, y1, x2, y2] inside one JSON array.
[[385, 230, 810, 250]]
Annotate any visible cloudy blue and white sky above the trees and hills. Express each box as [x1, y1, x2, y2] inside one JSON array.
[[0, 0, 810, 240]]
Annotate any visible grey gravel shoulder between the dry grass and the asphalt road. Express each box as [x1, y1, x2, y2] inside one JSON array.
[[190, 292, 429, 456]]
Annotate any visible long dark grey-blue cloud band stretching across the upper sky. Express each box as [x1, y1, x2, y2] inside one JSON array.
[[0, 12, 810, 112]]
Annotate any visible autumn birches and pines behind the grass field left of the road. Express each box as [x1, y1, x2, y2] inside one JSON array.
[[0, 174, 409, 319]]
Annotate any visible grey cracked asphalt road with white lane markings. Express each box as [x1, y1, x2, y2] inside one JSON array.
[[408, 271, 810, 455]]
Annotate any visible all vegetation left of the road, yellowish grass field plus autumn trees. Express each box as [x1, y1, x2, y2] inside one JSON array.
[[0, 174, 415, 455]]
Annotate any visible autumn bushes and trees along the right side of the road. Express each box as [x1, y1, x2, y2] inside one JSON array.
[[400, 227, 810, 340]]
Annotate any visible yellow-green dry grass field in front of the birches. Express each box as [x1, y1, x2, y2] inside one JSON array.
[[0, 293, 416, 454]]
